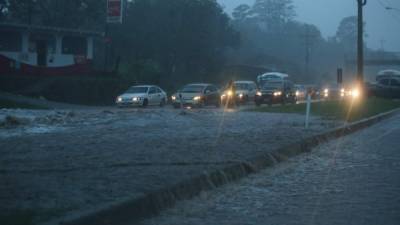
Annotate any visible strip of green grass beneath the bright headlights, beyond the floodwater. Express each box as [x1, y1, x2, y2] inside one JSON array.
[[251, 98, 400, 122]]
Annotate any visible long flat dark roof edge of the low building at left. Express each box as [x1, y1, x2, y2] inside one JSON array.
[[0, 22, 104, 36]]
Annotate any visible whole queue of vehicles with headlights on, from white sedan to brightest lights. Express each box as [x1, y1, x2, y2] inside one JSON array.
[[116, 72, 368, 108]]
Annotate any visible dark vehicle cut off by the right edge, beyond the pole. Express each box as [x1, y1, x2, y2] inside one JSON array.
[[373, 70, 400, 98]]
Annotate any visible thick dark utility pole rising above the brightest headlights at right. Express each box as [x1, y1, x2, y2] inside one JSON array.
[[357, 0, 367, 85]]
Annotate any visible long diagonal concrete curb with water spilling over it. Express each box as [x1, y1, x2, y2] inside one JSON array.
[[56, 109, 400, 225]]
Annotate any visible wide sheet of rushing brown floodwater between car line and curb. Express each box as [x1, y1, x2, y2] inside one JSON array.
[[0, 107, 337, 224]]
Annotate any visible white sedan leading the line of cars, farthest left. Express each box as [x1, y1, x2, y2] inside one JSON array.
[[116, 85, 167, 107]]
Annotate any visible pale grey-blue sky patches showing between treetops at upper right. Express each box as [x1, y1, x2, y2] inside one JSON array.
[[218, 0, 400, 52]]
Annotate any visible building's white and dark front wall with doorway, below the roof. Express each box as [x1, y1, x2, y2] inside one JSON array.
[[0, 28, 94, 73]]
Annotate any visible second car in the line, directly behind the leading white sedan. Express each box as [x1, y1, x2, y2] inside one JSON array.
[[171, 83, 221, 108]]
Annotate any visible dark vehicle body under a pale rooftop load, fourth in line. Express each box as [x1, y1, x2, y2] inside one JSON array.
[[255, 80, 297, 106]]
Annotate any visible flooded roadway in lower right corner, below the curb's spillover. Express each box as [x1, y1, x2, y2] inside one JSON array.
[[142, 115, 400, 225]]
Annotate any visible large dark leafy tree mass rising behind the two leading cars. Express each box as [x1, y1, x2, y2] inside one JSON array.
[[110, 0, 238, 87]]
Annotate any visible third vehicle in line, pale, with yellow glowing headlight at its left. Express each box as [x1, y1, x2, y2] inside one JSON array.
[[221, 81, 257, 105]]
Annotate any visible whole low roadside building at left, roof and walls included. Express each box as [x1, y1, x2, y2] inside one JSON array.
[[0, 23, 103, 75]]
